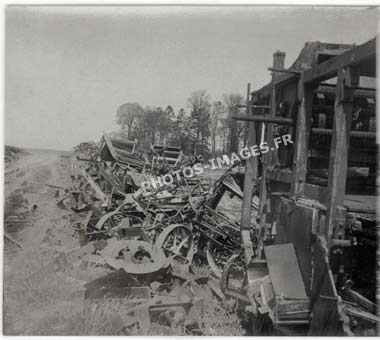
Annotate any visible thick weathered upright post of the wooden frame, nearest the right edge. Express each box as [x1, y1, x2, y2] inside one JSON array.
[[325, 68, 359, 247]]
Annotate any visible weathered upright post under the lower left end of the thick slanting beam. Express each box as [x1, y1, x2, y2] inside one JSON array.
[[290, 72, 313, 197]]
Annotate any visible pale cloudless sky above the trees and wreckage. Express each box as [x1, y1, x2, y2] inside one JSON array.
[[4, 6, 379, 150]]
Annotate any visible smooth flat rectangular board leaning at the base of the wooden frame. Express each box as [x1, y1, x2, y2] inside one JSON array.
[[264, 243, 307, 299]]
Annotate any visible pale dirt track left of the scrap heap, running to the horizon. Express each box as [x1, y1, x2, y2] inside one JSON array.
[[4, 150, 70, 247]]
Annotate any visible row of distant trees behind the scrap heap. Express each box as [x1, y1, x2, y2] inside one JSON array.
[[116, 90, 246, 157]]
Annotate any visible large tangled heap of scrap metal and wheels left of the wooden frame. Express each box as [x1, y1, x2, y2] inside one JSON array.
[[54, 134, 268, 334]]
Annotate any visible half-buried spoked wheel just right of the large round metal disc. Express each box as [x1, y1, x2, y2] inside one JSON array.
[[156, 224, 194, 264]]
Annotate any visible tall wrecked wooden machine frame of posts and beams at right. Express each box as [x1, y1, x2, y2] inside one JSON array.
[[234, 38, 378, 335]]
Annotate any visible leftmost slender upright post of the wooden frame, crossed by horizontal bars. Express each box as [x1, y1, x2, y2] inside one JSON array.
[[241, 84, 257, 263]]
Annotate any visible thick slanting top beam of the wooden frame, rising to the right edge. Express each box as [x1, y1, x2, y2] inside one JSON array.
[[304, 38, 376, 86]]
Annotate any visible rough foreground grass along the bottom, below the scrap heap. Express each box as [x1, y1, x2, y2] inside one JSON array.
[[3, 250, 244, 336]]
